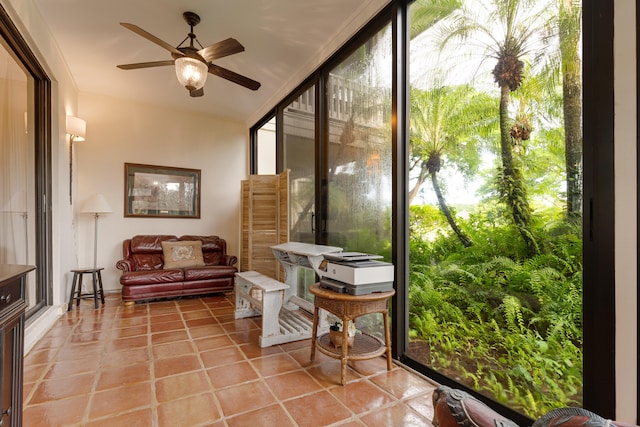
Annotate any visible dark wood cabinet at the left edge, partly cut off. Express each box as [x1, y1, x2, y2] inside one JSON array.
[[0, 265, 35, 427]]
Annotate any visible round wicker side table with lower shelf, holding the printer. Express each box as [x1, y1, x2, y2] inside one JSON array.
[[309, 283, 396, 385]]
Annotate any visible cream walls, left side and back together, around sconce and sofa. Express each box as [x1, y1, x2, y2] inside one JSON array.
[[1, 0, 248, 352]]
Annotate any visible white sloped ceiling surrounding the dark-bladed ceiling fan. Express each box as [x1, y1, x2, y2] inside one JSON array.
[[35, 0, 389, 125]]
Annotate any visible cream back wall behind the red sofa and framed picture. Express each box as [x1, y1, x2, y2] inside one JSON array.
[[74, 93, 249, 291]]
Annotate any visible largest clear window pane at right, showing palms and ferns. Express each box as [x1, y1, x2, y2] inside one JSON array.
[[407, 0, 583, 419]]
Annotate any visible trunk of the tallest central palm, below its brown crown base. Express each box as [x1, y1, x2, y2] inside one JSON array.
[[498, 84, 538, 256]]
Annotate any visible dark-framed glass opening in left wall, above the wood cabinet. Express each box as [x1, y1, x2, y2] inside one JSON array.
[[0, 2, 50, 319]]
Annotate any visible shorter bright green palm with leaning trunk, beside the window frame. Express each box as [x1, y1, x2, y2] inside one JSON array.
[[409, 82, 496, 247]]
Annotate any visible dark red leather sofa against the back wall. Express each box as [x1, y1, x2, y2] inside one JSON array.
[[116, 235, 238, 305]]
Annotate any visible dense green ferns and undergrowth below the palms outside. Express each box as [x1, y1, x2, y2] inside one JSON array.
[[409, 204, 582, 418]]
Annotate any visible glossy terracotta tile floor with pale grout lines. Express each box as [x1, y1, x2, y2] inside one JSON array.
[[23, 294, 435, 427]]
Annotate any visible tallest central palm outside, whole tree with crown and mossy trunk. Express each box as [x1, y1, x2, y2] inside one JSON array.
[[440, 0, 550, 255]]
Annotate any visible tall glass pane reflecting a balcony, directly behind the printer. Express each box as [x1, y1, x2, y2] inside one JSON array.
[[322, 24, 392, 260]]
